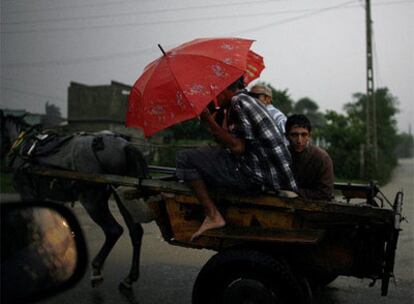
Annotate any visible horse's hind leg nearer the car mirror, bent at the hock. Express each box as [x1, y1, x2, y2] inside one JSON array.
[[81, 188, 123, 287]]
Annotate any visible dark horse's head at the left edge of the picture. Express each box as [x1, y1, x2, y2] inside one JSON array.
[[0, 110, 30, 159]]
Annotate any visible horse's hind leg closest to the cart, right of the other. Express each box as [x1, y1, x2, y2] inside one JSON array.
[[113, 190, 144, 290]]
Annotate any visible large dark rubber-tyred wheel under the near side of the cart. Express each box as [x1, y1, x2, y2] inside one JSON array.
[[192, 250, 309, 304]]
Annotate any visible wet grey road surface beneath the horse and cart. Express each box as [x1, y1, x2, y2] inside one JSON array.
[[41, 159, 414, 304]]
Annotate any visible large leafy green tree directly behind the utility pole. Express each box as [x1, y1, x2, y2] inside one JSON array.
[[323, 88, 398, 183]]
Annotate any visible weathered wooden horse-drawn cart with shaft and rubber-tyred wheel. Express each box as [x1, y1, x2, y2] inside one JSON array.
[[33, 166, 403, 304]]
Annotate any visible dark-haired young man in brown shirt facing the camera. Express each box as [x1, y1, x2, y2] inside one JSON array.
[[285, 114, 335, 200]]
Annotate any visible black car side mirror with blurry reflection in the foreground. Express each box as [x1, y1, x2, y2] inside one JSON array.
[[0, 202, 87, 303]]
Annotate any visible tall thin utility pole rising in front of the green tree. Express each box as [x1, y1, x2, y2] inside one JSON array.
[[365, 0, 378, 178]]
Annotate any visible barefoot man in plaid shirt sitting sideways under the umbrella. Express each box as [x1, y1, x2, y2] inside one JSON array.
[[176, 79, 297, 240]]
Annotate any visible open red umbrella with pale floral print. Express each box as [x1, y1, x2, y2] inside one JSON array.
[[126, 38, 264, 136]]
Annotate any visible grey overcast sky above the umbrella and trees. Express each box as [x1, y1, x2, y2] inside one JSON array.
[[0, 0, 414, 132]]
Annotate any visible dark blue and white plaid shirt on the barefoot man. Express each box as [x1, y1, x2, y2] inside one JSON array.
[[228, 91, 297, 191]]
